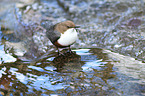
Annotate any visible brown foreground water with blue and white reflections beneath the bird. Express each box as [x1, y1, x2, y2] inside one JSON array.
[[0, 48, 144, 96]]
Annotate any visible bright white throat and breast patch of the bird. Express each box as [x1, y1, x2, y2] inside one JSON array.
[[58, 28, 78, 46]]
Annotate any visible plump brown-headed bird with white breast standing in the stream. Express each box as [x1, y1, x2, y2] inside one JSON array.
[[46, 21, 79, 54]]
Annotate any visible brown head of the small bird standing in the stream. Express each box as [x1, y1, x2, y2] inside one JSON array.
[[55, 21, 76, 34]]
